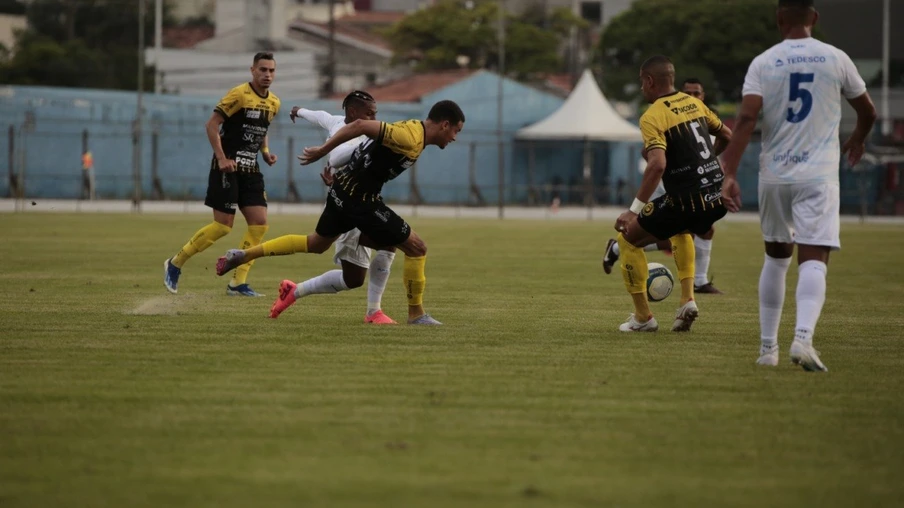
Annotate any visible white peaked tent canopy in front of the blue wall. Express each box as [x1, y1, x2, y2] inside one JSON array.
[[515, 70, 642, 141]]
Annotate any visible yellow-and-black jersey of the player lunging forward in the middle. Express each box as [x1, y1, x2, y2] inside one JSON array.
[[336, 120, 425, 200]]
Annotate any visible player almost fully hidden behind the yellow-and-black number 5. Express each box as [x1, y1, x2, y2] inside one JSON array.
[[603, 78, 725, 295]]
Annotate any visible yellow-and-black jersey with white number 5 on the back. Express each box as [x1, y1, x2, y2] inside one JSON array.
[[640, 92, 724, 194]]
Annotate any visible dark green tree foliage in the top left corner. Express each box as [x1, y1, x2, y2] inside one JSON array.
[[0, 0, 169, 90]]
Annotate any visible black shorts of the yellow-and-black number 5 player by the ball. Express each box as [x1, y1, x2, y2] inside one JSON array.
[[637, 187, 728, 240]]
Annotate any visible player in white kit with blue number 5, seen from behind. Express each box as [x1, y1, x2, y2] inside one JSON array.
[[722, 0, 876, 371]]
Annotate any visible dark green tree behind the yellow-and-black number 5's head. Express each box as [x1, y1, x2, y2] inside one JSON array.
[[598, 0, 816, 101]]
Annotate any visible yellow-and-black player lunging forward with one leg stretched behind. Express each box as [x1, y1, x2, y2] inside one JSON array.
[[217, 101, 465, 325]]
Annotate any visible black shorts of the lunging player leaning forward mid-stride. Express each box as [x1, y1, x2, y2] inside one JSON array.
[[316, 186, 411, 247]]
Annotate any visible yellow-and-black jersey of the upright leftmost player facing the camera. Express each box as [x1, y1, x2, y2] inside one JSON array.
[[214, 83, 279, 171]]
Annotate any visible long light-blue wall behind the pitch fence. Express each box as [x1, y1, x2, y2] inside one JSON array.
[[0, 82, 879, 207]]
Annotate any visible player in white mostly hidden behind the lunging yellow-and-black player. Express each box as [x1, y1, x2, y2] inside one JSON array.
[[286, 90, 396, 325]]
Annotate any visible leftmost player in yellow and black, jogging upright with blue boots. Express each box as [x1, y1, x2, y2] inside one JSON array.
[[163, 53, 279, 296]]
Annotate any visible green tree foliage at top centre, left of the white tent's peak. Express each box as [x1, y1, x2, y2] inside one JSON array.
[[385, 0, 584, 77]]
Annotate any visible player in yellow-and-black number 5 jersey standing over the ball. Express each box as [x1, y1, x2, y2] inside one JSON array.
[[615, 56, 731, 332]]
